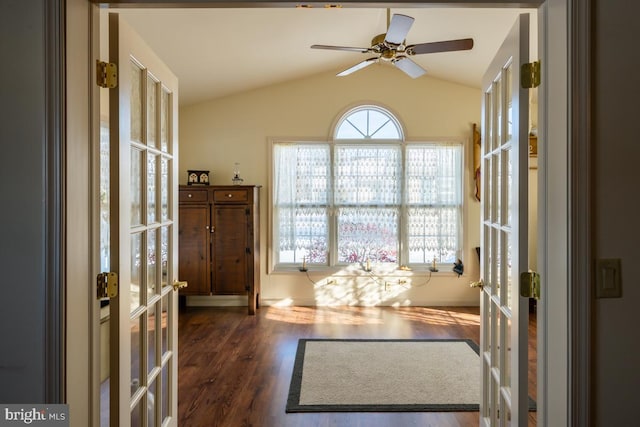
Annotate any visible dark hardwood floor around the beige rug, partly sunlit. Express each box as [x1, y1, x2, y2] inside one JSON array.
[[178, 307, 536, 427]]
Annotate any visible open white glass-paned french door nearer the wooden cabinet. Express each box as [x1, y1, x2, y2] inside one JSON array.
[[109, 14, 178, 427]]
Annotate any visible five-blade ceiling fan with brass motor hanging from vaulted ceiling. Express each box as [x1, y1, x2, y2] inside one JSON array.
[[311, 9, 473, 79]]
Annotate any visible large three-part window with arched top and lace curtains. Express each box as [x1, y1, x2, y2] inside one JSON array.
[[272, 105, 462, 268]]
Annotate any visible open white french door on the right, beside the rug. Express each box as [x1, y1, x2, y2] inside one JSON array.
[[480, 14, 529, 426]]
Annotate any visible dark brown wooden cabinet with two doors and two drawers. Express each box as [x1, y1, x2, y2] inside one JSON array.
[[178, 185, 260, 314]]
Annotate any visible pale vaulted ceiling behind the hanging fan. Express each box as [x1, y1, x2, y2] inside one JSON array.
[[111, 7, 537, 106]]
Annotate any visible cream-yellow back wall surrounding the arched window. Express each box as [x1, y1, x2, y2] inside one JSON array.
[[179, 65, 481, 305]]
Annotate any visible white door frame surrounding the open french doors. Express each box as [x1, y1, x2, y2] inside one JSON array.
[[61, 0, 592, 426]]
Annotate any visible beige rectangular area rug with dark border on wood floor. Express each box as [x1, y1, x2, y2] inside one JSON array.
[[286, 339, 480, 412]]
